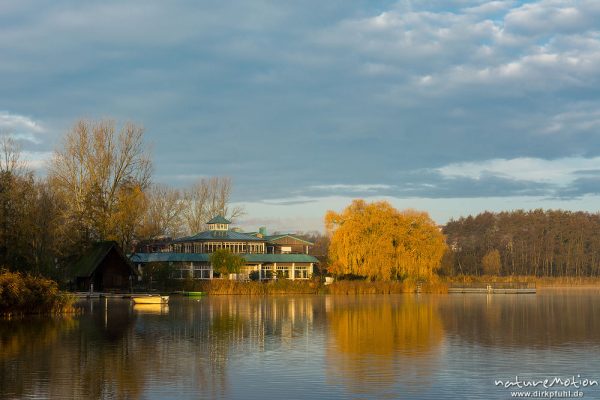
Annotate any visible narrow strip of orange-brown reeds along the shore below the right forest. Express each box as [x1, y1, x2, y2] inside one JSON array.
[[447, 275, 600, 288]]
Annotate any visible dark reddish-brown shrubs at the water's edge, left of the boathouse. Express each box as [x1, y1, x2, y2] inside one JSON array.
[[0, 271, 75, 316]]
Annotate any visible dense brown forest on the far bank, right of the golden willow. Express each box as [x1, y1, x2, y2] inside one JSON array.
[[440, 210, 600, 277]]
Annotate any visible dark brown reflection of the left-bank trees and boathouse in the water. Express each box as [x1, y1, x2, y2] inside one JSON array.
[[0, 300, 143, 398]]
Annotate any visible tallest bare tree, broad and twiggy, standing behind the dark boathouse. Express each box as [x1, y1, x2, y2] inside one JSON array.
[[49, 120, 151, 247]]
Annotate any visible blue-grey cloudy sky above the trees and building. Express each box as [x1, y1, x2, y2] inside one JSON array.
[[0, 0, 600, 231]]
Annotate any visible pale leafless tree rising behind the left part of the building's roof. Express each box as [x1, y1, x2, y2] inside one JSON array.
[[184, 177, 244, 233]]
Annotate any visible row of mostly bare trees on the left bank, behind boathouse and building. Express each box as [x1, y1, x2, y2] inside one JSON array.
[[0, 120, 243, 281]]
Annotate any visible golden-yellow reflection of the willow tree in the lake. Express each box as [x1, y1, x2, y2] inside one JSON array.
[[326, 295, 443, 396]]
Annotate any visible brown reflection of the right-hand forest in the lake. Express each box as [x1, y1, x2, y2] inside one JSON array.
[[440, 289, 600, 348]]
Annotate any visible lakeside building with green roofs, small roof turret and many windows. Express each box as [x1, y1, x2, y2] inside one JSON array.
[[131, 216, 318, 280]]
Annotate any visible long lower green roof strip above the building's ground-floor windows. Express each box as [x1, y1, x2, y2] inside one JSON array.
[[129, 253, 319, 264]]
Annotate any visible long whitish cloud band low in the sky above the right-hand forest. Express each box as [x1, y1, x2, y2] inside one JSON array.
[[435, 157, 600, 185]]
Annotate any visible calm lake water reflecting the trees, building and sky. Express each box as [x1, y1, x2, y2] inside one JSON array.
[[0, 290, 600, 399]]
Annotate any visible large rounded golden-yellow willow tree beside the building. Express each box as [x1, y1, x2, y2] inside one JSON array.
[[325, 200, 446, 281]]
